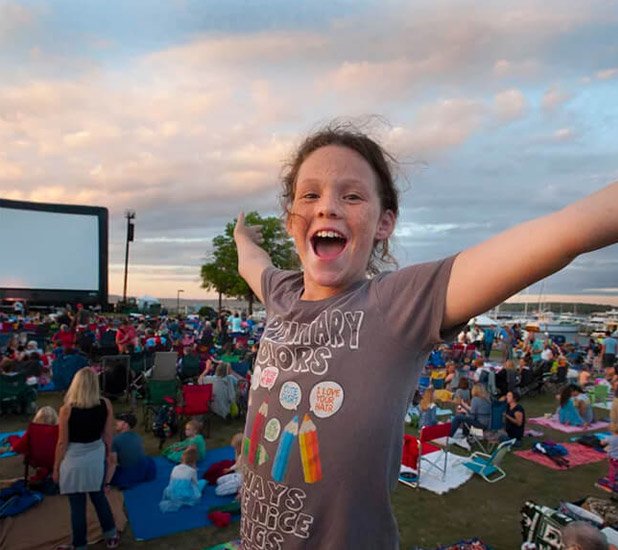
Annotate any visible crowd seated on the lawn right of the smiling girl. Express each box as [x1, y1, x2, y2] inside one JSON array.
[[414, 325, 618, 441]]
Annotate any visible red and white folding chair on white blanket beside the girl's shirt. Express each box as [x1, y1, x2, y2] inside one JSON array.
[[401, 422, 451, 487]]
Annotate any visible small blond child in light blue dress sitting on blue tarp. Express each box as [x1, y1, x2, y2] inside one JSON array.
[[159, 445, 206, 513]]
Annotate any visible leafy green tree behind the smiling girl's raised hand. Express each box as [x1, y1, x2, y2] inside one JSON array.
[[201, 212, 299, 315]]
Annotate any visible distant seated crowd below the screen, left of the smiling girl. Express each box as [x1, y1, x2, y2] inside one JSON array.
[[0, 305, 263, 414]]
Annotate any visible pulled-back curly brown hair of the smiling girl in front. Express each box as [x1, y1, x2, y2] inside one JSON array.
[[281, 122, 399, 275]]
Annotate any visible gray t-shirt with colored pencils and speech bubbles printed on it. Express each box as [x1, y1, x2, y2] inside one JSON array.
[[241, 257, 459, 550]]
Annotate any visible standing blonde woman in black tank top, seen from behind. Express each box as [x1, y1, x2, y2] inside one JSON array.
[[54, 367, 119, 550]]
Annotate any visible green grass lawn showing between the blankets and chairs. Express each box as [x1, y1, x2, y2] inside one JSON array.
[[0, 386, 607, 550]]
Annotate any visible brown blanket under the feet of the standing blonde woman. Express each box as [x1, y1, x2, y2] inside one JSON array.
[[0, 490, 127, 550]]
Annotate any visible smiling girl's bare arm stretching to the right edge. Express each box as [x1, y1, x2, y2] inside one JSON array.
[[443, 183, 618, 328]]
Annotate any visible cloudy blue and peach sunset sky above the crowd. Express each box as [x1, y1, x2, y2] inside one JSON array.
[[0, 0, 618, 303]]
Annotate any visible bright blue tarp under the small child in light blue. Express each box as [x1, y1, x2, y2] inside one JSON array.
[[123, 447, 235, 540]]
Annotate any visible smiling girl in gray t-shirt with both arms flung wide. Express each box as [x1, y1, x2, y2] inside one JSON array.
[[234, 128, 618, 550]]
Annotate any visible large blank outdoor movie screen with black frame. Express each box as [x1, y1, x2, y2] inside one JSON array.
[[0, 199, 107, 303]]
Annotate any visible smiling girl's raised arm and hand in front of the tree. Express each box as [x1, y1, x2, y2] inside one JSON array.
[[234, 212, 272, 303]]
